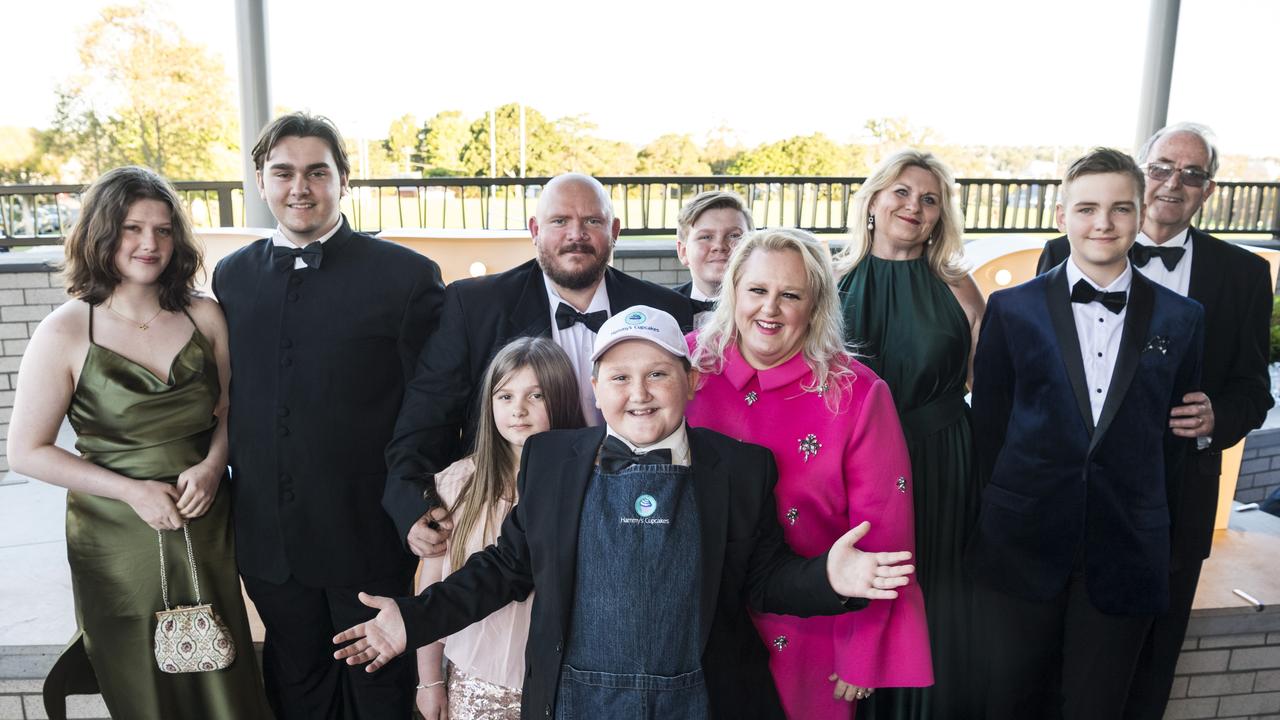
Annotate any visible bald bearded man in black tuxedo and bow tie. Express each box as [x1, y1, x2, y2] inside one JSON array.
[[383, 173, 692, 557]]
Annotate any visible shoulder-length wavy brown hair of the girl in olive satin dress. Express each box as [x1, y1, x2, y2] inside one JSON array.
[[63, 165, 204, 313]]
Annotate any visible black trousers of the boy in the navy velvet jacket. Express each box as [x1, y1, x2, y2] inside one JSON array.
[[975, 574, 1152, 720]]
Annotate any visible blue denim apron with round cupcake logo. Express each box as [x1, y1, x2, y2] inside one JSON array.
[[556, 465, 708, 720]]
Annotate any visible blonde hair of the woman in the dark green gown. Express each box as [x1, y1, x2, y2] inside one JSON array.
[[832, 149, 968, 283]]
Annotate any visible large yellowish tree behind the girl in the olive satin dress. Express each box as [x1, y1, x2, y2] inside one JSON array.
[[46, 4, 238, 179]]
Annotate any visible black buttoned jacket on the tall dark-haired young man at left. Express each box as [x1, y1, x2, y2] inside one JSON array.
[[214, 219, 444, 587]]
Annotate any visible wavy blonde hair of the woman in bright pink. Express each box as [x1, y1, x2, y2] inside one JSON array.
[[691, 228, 854, 411]]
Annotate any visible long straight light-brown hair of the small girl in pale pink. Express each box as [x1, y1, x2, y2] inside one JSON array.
[[449, 337, 586, 569]]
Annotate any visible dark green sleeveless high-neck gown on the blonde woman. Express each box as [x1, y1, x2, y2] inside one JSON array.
[[840, 255, 980, 720]]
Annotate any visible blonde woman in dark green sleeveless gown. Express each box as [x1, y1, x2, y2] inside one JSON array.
[[835, 150, 984, 719]]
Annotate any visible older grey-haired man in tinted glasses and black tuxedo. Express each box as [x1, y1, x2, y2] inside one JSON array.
[[1038, 123, 1272, 720]]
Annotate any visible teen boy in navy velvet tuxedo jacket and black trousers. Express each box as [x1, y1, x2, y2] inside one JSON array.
[[968, 149, 1203, 720]]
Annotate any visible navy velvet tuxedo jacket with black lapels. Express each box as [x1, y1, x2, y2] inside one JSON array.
[[966, 265, 1203, 615]]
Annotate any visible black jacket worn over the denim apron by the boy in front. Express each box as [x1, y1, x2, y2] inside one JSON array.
[[398, 427, 867, 720]]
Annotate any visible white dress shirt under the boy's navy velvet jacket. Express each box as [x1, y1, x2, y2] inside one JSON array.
[[1066, 258, 1136, 425]]
